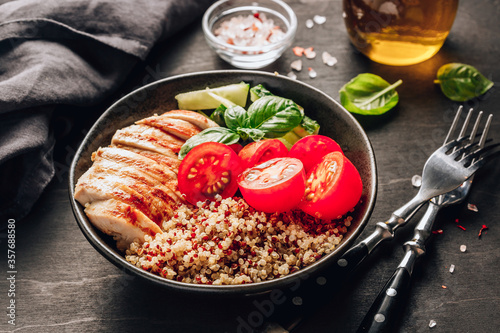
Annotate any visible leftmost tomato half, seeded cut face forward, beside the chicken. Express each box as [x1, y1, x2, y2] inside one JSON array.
[[177, 142, 243, 205]]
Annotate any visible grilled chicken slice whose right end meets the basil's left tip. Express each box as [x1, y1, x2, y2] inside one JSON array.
[[111, 125, 184, 158]]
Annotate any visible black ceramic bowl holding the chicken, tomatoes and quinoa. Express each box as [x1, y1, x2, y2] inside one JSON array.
[[69, 70, 377, 295]]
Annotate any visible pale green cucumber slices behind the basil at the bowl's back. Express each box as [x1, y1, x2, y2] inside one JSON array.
[[175, 82, 250, 110]]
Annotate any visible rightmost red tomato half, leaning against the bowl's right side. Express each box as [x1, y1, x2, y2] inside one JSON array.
[[299, 152, 363, 220]]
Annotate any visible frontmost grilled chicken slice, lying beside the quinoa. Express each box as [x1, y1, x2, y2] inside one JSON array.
[[85, 199, 162, 251]]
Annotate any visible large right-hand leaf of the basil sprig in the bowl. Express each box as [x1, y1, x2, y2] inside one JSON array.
[[244, 96, 304, 138]]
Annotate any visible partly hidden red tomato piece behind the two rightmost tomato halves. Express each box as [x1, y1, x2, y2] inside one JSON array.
[[288, 135, 342, 173]]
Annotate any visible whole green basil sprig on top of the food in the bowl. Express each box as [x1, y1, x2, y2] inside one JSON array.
[[179, 96, 304, 160]]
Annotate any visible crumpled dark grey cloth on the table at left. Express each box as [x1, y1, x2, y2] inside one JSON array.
[[0, 0, 213, 226]]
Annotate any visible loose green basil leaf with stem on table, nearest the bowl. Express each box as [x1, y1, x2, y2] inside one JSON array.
[[340, 73, 403, 115]]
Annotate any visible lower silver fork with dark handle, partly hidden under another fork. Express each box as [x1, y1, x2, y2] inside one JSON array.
[[358, 109, 492, 333]]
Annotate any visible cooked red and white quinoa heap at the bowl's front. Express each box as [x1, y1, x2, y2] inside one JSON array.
[[125, 197, 352, 285]]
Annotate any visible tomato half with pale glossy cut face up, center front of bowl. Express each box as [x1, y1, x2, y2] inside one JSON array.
[[238, 157, 305, 213]]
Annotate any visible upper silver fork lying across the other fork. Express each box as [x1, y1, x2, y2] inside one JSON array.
[[337, 107, 498, 276]]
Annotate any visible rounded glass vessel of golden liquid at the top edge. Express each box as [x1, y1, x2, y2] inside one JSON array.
[[343, 0, 458, 66]]
